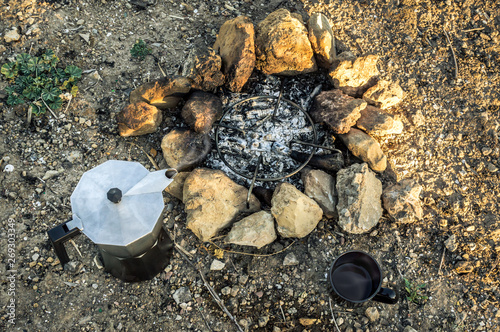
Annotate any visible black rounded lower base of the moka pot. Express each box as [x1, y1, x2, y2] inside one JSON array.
[[99, 227, 174, 282]]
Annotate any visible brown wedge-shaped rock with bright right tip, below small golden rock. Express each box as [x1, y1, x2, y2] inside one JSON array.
[[356, 105, 403, 136]]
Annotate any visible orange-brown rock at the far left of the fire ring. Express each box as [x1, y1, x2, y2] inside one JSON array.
[[116, 102, 162, 137]]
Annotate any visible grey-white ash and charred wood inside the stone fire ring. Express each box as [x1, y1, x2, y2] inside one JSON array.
[[205, 75, 333, 189]]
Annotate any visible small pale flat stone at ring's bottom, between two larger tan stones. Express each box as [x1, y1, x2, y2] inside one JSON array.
[[224, 211, 277, 249]]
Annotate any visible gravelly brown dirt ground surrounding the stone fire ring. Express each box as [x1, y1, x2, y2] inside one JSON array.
[[0, 0, 500, 331]]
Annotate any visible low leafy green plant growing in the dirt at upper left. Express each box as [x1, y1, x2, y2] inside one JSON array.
[[1, 50, 82, 115]]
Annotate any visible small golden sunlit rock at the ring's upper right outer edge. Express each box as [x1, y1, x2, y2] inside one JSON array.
[[363, 80, 404, 109]]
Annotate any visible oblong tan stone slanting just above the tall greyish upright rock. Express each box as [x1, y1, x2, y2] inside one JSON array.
[[340, 128, 387, 172]]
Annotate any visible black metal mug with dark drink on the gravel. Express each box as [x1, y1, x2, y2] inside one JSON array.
[[328, 250, 398, 304]]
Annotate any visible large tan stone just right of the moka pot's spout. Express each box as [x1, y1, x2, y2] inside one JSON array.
[[183, 168, 260, 241]]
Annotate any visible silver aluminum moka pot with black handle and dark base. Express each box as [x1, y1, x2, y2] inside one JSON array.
[[47, 160, 177, 282]]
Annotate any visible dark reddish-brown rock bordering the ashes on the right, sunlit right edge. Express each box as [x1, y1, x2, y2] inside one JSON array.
[[310, 89, 367, 134]]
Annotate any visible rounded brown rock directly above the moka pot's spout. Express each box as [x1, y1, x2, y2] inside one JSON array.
[[161, 128, 212, 172]]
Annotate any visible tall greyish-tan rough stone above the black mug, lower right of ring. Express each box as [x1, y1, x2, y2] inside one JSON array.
[[337, 163, 382, 234]]
